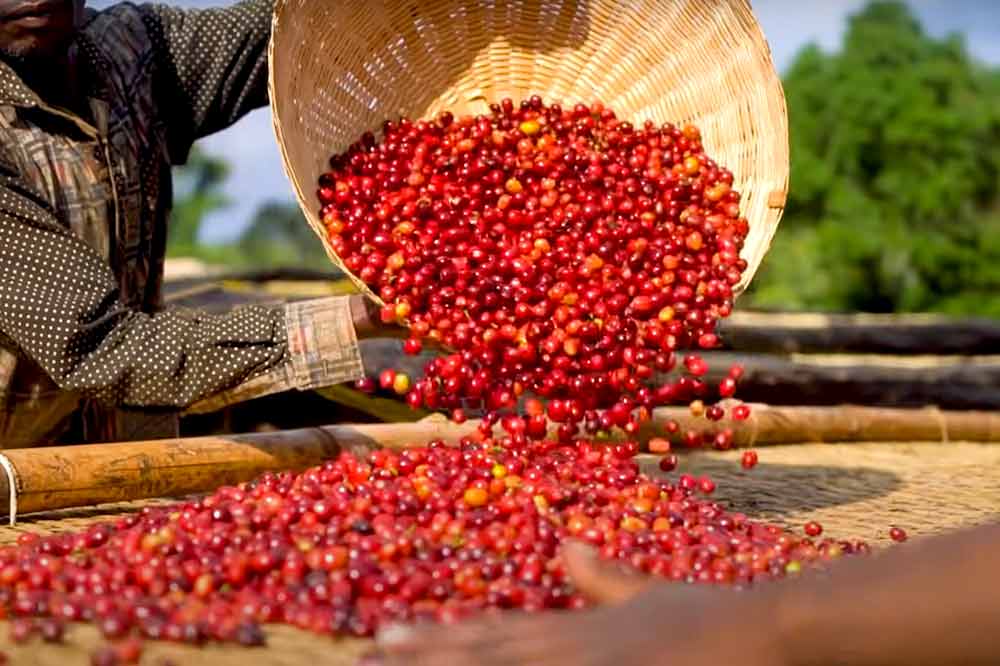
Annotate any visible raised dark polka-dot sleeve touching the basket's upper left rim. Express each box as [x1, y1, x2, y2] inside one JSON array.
[[142, 0, 274, 163]]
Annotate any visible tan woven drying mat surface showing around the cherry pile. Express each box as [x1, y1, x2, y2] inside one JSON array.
[[0, 443, 1000, 666]]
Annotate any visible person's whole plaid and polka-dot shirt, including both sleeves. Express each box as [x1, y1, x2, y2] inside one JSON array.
[[0, 0, 363, 448]]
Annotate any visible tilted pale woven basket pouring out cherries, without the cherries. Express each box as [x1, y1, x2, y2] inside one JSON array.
[[270, 0, 788, 301]]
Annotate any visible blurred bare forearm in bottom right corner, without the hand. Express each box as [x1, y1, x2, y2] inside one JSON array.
[[774, 525, 1000, 666]]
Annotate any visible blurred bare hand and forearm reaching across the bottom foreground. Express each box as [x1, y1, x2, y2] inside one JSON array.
[[373, 524, 1000, 666]]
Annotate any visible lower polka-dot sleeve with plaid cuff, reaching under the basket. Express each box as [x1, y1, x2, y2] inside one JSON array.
[[0, 178, 363, 409]]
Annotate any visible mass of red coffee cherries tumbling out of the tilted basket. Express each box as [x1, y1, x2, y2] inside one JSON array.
[[318, 97, 748, 434]]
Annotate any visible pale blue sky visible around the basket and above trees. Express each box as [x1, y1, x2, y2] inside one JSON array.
[[89, 0, 1000, 242]]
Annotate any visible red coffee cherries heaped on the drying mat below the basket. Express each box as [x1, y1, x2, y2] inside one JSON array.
[[0, 428, 867, 652]]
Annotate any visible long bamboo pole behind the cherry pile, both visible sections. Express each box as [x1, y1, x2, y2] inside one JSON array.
[[0, 405, 1000, 519]]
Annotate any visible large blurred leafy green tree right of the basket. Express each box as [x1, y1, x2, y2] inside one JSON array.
[[748, 1, 1000, 316]]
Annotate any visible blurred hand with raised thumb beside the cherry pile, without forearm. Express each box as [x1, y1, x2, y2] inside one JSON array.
[[376, 545, 784, 666]]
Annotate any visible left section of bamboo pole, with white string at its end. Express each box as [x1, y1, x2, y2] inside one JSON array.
[[0, 418, 476, 516]]
